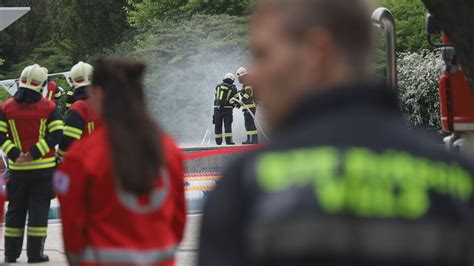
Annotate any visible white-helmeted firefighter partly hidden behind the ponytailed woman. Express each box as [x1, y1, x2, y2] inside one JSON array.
[[58, 61, 97, 157]]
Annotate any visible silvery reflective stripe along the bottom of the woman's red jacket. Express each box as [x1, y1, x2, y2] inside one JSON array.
[[80, 246, 177, 265]]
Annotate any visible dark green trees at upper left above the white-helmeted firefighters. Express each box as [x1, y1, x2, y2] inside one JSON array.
[[0, 0, 129, 79]]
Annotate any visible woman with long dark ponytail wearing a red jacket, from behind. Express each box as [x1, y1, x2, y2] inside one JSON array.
[[54, 58, 186, 266]]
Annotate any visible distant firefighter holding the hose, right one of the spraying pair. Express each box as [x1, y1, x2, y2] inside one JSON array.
[[237, 67, 258, 145]]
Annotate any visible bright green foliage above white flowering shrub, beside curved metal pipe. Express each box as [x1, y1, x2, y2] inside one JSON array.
[[379, 0, 432, 53]]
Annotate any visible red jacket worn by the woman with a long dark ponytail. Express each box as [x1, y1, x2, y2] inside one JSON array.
[[54, 126, 186, 266]]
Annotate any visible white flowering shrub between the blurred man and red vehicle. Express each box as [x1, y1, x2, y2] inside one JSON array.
[[398, 51, 443, 132]]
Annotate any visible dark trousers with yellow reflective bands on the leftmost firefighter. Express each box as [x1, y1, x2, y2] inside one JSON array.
[[5, 169, 54, 259]]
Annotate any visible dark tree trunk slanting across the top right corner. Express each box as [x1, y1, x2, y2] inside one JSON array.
[[422, 0, 474, 91]]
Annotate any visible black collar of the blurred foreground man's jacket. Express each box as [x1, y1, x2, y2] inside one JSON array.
[[283, 84, 400, 127]]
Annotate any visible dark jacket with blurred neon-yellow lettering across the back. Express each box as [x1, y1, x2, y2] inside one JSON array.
[[199, 84, 474, 266]]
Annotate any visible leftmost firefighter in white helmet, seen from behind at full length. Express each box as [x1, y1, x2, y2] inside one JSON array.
[[0, 65, 64, 263]]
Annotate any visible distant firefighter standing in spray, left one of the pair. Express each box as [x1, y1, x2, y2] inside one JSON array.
[[212, 73, 237, 145]]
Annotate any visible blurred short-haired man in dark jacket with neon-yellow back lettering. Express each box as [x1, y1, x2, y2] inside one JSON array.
[[199, 0, 474, 266]]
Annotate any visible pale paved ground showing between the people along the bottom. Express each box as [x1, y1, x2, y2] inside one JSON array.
[[0, 215, 201, 266]]
